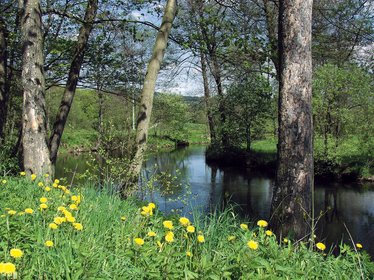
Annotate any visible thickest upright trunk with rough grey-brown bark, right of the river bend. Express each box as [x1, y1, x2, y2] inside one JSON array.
[[271, 0, 313, 239]]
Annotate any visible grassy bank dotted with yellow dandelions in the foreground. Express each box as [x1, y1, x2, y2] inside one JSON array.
[[0, 176, 374, 279]]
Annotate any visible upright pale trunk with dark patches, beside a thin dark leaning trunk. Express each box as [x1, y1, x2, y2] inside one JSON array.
[[21, 0, 52, 174]]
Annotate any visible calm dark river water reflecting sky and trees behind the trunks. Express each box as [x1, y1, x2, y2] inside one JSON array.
[[56, 146, 374, 258]]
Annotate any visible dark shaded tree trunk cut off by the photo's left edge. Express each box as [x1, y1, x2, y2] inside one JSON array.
[[0, 16, 9, 144]]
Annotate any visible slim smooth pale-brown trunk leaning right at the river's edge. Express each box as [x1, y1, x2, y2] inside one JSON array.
[[122, 0, 177, 192]]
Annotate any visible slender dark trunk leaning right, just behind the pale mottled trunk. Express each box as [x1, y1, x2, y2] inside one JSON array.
[[49, 0, 98, 165]]
